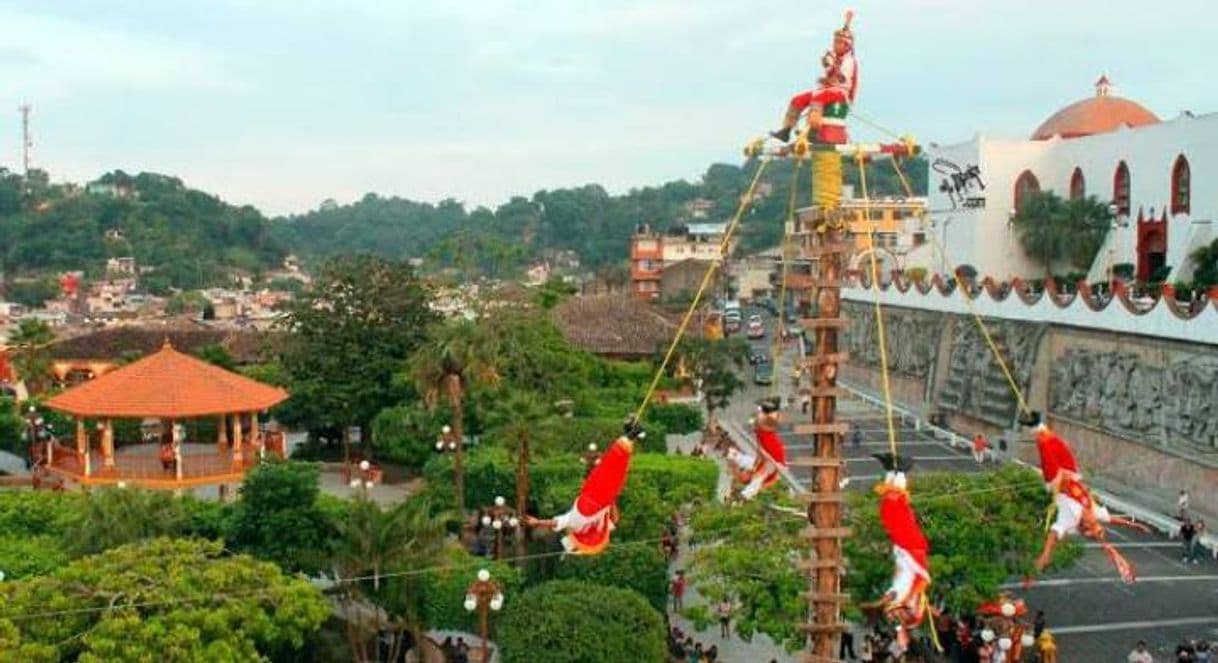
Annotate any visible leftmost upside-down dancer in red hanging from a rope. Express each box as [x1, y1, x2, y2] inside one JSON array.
[[525, 419, 643, 555]]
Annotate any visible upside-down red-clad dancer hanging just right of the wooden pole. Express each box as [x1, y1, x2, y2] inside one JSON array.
[[861, 453, 931, 647]]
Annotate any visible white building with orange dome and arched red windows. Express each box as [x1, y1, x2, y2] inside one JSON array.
[[906, 78, 1218, 282]]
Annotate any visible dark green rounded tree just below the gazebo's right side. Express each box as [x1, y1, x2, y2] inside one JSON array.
[[225, 462, 335, 572]]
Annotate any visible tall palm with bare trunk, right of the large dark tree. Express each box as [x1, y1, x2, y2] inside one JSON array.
[[410, 321, 498, 519]]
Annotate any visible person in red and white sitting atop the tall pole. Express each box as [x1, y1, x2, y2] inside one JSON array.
[[770, 12, 859, 144]]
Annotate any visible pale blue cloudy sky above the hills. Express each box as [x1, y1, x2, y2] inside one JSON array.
[[0, 0, 1218, 215]]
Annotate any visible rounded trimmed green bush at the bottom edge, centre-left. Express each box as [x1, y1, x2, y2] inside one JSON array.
[[497, 580, 666, 663]]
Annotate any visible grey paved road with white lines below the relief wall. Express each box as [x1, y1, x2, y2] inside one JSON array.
[[722, 308, 1218, 663]]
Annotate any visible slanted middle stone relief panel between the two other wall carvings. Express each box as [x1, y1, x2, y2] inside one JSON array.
[[939, 317, 1046, 428]]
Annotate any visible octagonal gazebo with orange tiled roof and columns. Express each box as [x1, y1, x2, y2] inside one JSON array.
[[45, 341, 287, 489]]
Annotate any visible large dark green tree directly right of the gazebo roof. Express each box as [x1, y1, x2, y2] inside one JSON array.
[[283, 255, 436, 455]]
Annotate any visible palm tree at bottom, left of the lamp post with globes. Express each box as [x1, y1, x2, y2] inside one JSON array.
[[333, 496, 447, 662]]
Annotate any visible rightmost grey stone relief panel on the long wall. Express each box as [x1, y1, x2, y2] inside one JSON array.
[[1049, 349, 1218, 451]]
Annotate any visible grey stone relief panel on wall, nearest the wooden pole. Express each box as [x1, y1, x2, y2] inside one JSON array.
[[843, 302, 943, 379]]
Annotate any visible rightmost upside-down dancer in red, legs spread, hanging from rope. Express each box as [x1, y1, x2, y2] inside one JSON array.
[[1019, 412, 1147, 584]]
